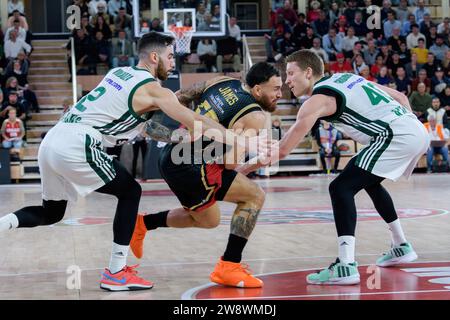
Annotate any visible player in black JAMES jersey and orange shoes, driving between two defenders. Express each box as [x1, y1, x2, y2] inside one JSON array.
[[131, 62, 282, 288]]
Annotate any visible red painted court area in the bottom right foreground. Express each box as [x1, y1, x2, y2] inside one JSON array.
[[183, 261, 450, 300]]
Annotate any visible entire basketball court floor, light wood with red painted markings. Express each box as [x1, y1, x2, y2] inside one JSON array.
[[0, 174, 450, 300]]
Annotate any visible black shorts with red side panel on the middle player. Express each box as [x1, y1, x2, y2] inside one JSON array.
[[159, 144, 237, 211]]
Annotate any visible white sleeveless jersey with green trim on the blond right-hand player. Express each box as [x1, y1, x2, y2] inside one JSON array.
[[313, 73, 416, 144]]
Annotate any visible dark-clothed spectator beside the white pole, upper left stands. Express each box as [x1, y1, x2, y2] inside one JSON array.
[[66, 29, 97, 82]]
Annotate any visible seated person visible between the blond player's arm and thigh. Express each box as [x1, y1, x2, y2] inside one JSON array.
[[316, 120, 341, 173]]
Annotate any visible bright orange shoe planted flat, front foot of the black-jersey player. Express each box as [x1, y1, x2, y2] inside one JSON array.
[[210, 257, 263, 288]]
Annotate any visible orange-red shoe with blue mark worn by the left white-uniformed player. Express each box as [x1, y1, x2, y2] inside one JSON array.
[[100, 265, 153, 291]]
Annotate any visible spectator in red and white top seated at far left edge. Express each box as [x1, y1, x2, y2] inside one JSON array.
[[1, 108, 25, 154]]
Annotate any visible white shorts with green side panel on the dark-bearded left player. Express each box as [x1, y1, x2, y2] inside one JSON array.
[[38, 122, 116, 201]]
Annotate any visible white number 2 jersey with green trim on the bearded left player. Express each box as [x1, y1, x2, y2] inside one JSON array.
[[61, 67, 155, 145]]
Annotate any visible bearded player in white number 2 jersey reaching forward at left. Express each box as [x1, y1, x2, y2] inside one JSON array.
[[0, 32, 268, 291]]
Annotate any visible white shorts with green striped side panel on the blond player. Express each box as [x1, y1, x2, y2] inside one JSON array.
[[355, 115, 430, 181]]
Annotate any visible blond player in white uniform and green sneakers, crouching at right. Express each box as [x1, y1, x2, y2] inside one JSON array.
[[240, 50, 429, 285]]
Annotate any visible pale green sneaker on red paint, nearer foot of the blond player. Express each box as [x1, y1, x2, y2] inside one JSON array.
[[306, 258, 360, 285]]
